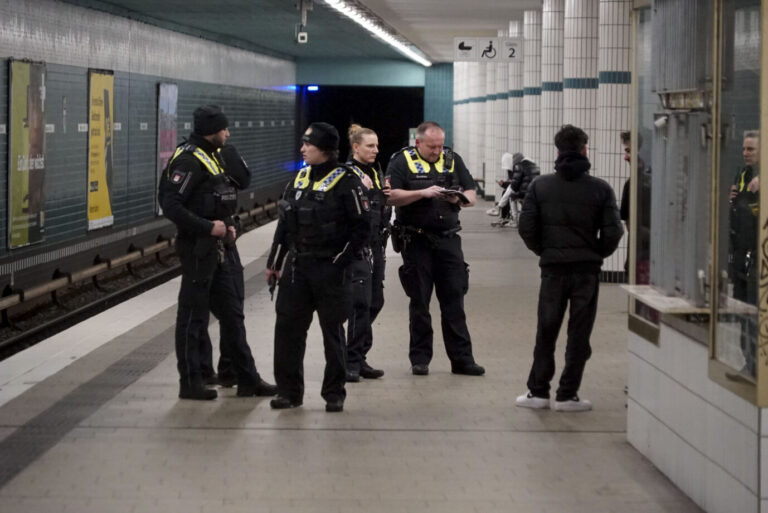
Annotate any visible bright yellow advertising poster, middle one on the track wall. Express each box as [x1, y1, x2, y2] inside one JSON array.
[[88, 71, 115, 230]]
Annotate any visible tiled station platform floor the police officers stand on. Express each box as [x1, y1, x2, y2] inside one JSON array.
[[0, 202, 700, 513]]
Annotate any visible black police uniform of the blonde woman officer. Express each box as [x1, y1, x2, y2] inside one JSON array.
[[347, 159, 392, 380]]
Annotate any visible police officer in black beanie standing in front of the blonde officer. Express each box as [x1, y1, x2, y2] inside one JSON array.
[[267, 123, 370, 412]]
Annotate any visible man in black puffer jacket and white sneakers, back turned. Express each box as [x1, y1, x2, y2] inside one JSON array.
[[516, 125, 624, 411]]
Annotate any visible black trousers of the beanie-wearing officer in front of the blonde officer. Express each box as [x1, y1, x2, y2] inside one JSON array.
[[275, 254, 349, 402]]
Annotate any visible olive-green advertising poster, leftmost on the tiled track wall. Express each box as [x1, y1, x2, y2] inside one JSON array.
[[8, 60, 45, 248]]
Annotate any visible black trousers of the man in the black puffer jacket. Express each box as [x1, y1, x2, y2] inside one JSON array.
[[528, 270, 599, 401]]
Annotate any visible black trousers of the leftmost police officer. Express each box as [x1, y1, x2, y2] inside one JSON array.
[[176, 238, 259, 385]]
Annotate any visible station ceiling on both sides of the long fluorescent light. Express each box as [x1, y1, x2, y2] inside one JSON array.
[[58, 0, 541, 62]]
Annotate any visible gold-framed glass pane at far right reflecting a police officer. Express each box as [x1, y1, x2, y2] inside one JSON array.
[[715, 0, 760, 378]]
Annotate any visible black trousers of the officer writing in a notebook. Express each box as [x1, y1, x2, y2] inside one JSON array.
[[400, 234, 475, 367]]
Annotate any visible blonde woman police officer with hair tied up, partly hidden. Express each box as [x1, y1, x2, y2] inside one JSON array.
[[347, 125, 392, 382]]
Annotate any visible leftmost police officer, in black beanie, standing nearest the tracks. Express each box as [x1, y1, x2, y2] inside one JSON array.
[[159, 105, 275, 400]]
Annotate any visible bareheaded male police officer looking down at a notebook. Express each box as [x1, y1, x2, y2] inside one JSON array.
[[387, 121, 485, 376]]
